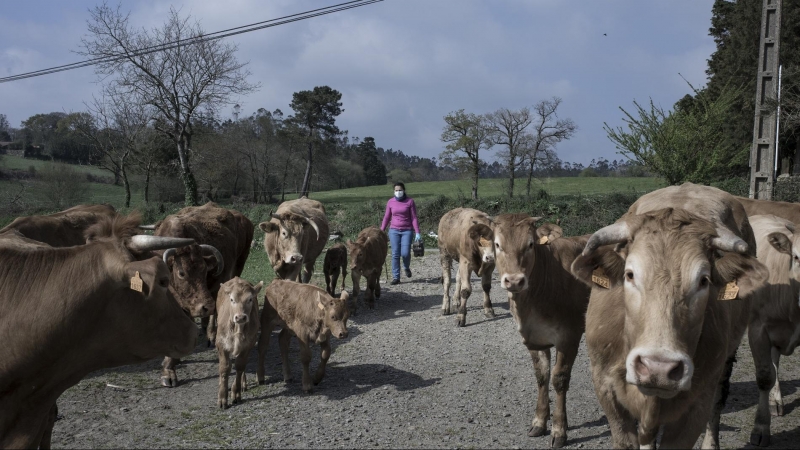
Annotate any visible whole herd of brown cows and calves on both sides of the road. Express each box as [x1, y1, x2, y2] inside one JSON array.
[[0, 183, 800, 448]]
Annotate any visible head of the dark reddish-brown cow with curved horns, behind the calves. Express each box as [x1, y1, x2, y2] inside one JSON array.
[[163, 244, 225, 317]]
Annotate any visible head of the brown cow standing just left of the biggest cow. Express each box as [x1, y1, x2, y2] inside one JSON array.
[[494, 214, 541, 293]]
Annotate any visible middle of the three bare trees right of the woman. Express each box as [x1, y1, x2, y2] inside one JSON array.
[[486, 107, 533, 198]]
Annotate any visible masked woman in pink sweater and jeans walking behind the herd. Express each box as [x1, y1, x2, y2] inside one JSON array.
[[381, 182, 422, 284]]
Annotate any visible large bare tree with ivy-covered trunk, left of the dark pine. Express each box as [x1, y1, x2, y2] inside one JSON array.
[[78, 4, 258, 205]]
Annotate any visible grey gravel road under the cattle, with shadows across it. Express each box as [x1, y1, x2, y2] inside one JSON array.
[[53, 250, 800, 448]]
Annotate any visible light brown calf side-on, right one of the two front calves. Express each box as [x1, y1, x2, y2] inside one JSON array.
[[257, 280, 350, 393]]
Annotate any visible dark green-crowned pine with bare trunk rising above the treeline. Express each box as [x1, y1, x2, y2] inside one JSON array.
[[289, 86, 344, 196]]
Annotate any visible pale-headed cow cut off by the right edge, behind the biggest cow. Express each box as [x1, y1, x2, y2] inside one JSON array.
[[748, 215, 800, 446]]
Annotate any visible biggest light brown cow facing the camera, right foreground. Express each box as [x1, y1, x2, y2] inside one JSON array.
[[572, 183, 768, 448]]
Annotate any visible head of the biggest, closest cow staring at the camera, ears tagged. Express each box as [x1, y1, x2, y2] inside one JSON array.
[[572, 209, 768, 398]]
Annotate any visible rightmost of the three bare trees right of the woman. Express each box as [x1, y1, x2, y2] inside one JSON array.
[[521, 97, 578, 197]]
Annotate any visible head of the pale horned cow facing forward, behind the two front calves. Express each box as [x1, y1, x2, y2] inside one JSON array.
[[258, 213, 319, 267]]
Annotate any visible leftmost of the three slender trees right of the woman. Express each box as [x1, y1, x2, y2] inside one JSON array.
[[439, 109, 492, 200]]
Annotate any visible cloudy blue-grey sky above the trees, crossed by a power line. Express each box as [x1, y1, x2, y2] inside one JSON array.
[[0, 0, 716, 164]]
